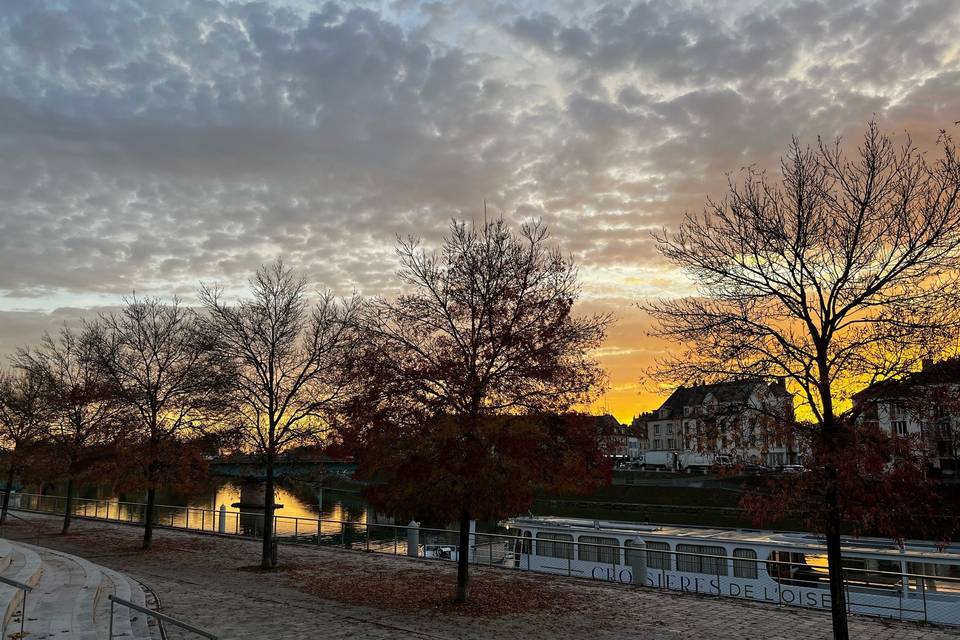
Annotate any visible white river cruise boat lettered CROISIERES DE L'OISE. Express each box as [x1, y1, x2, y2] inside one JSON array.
[[502, 517, 960, 625]]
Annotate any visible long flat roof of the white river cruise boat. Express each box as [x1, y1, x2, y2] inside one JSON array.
[[504, 516, 960, 561]]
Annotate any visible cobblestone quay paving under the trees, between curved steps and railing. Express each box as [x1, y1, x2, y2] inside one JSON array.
[[3, 513, 960, 640]]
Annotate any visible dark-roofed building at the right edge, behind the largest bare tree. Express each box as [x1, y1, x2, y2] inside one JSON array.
[[853, 358, 960, 475]]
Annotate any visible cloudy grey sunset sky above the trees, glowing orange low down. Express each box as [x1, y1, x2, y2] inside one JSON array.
[[0, 0, 960, 421]]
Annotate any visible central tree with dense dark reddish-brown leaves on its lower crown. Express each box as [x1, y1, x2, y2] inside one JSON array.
[[355, 220, 610, 602]]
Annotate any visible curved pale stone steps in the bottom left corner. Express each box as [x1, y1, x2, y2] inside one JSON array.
[[0, 539, 152, 640]]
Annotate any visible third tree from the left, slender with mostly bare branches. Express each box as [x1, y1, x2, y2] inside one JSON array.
[[88, 297, 230, 549]]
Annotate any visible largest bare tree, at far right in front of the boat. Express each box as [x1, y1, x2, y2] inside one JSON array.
[[645, 122, 960, 639]]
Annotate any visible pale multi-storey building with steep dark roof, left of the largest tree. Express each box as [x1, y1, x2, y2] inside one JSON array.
[[633, 378, 800, 466]]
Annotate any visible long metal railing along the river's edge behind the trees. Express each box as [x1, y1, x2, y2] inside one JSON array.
[[11, 494, 960, 624]]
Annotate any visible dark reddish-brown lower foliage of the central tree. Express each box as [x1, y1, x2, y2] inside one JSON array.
[[358, 414, 610, 524]]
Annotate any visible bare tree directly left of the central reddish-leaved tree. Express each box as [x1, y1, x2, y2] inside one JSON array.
[[200, 260, 357, 568]]
